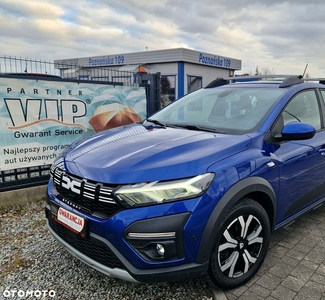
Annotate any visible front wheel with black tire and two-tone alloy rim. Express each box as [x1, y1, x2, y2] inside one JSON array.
[[208, 198, 271, 289]]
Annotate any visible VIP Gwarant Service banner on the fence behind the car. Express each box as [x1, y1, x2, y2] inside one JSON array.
[[0, 78, 147, 171]]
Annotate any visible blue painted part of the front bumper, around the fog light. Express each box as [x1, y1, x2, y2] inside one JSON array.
[[48, 176, 216, 268]]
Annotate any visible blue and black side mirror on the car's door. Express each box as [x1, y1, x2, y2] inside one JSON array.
[[274, 122, 316, 141]]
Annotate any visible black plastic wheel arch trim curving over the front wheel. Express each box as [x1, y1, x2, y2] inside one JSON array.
[[196, 177, 277, 264]]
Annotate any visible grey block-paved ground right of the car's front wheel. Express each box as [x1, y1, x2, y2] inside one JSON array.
[[214, 205, 325, 300]]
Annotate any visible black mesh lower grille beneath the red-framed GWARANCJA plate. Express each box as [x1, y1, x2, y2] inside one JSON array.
[[48, 217, 125, 269]]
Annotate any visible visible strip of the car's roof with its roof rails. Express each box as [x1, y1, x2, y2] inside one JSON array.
[[205, 75, 325, 88]]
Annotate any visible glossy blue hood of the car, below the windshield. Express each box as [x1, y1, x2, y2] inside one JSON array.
[[60, 124, 250, 184]]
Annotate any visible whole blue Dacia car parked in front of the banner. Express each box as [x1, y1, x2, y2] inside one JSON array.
[[46, 76, 325, 289]]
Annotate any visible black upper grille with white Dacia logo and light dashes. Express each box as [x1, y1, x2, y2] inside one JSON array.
[[50, 167, 123, 219]]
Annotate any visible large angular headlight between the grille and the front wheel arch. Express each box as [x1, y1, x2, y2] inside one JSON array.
[[115, 173, 214, 206]]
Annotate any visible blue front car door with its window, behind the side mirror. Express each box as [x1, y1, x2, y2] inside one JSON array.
[[274, 90, 325, 223]]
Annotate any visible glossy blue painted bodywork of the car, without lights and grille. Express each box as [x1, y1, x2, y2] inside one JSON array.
[[48, 76, 325, 288]]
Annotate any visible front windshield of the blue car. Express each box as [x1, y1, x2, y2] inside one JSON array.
[[150, 86, 284, 134]]
